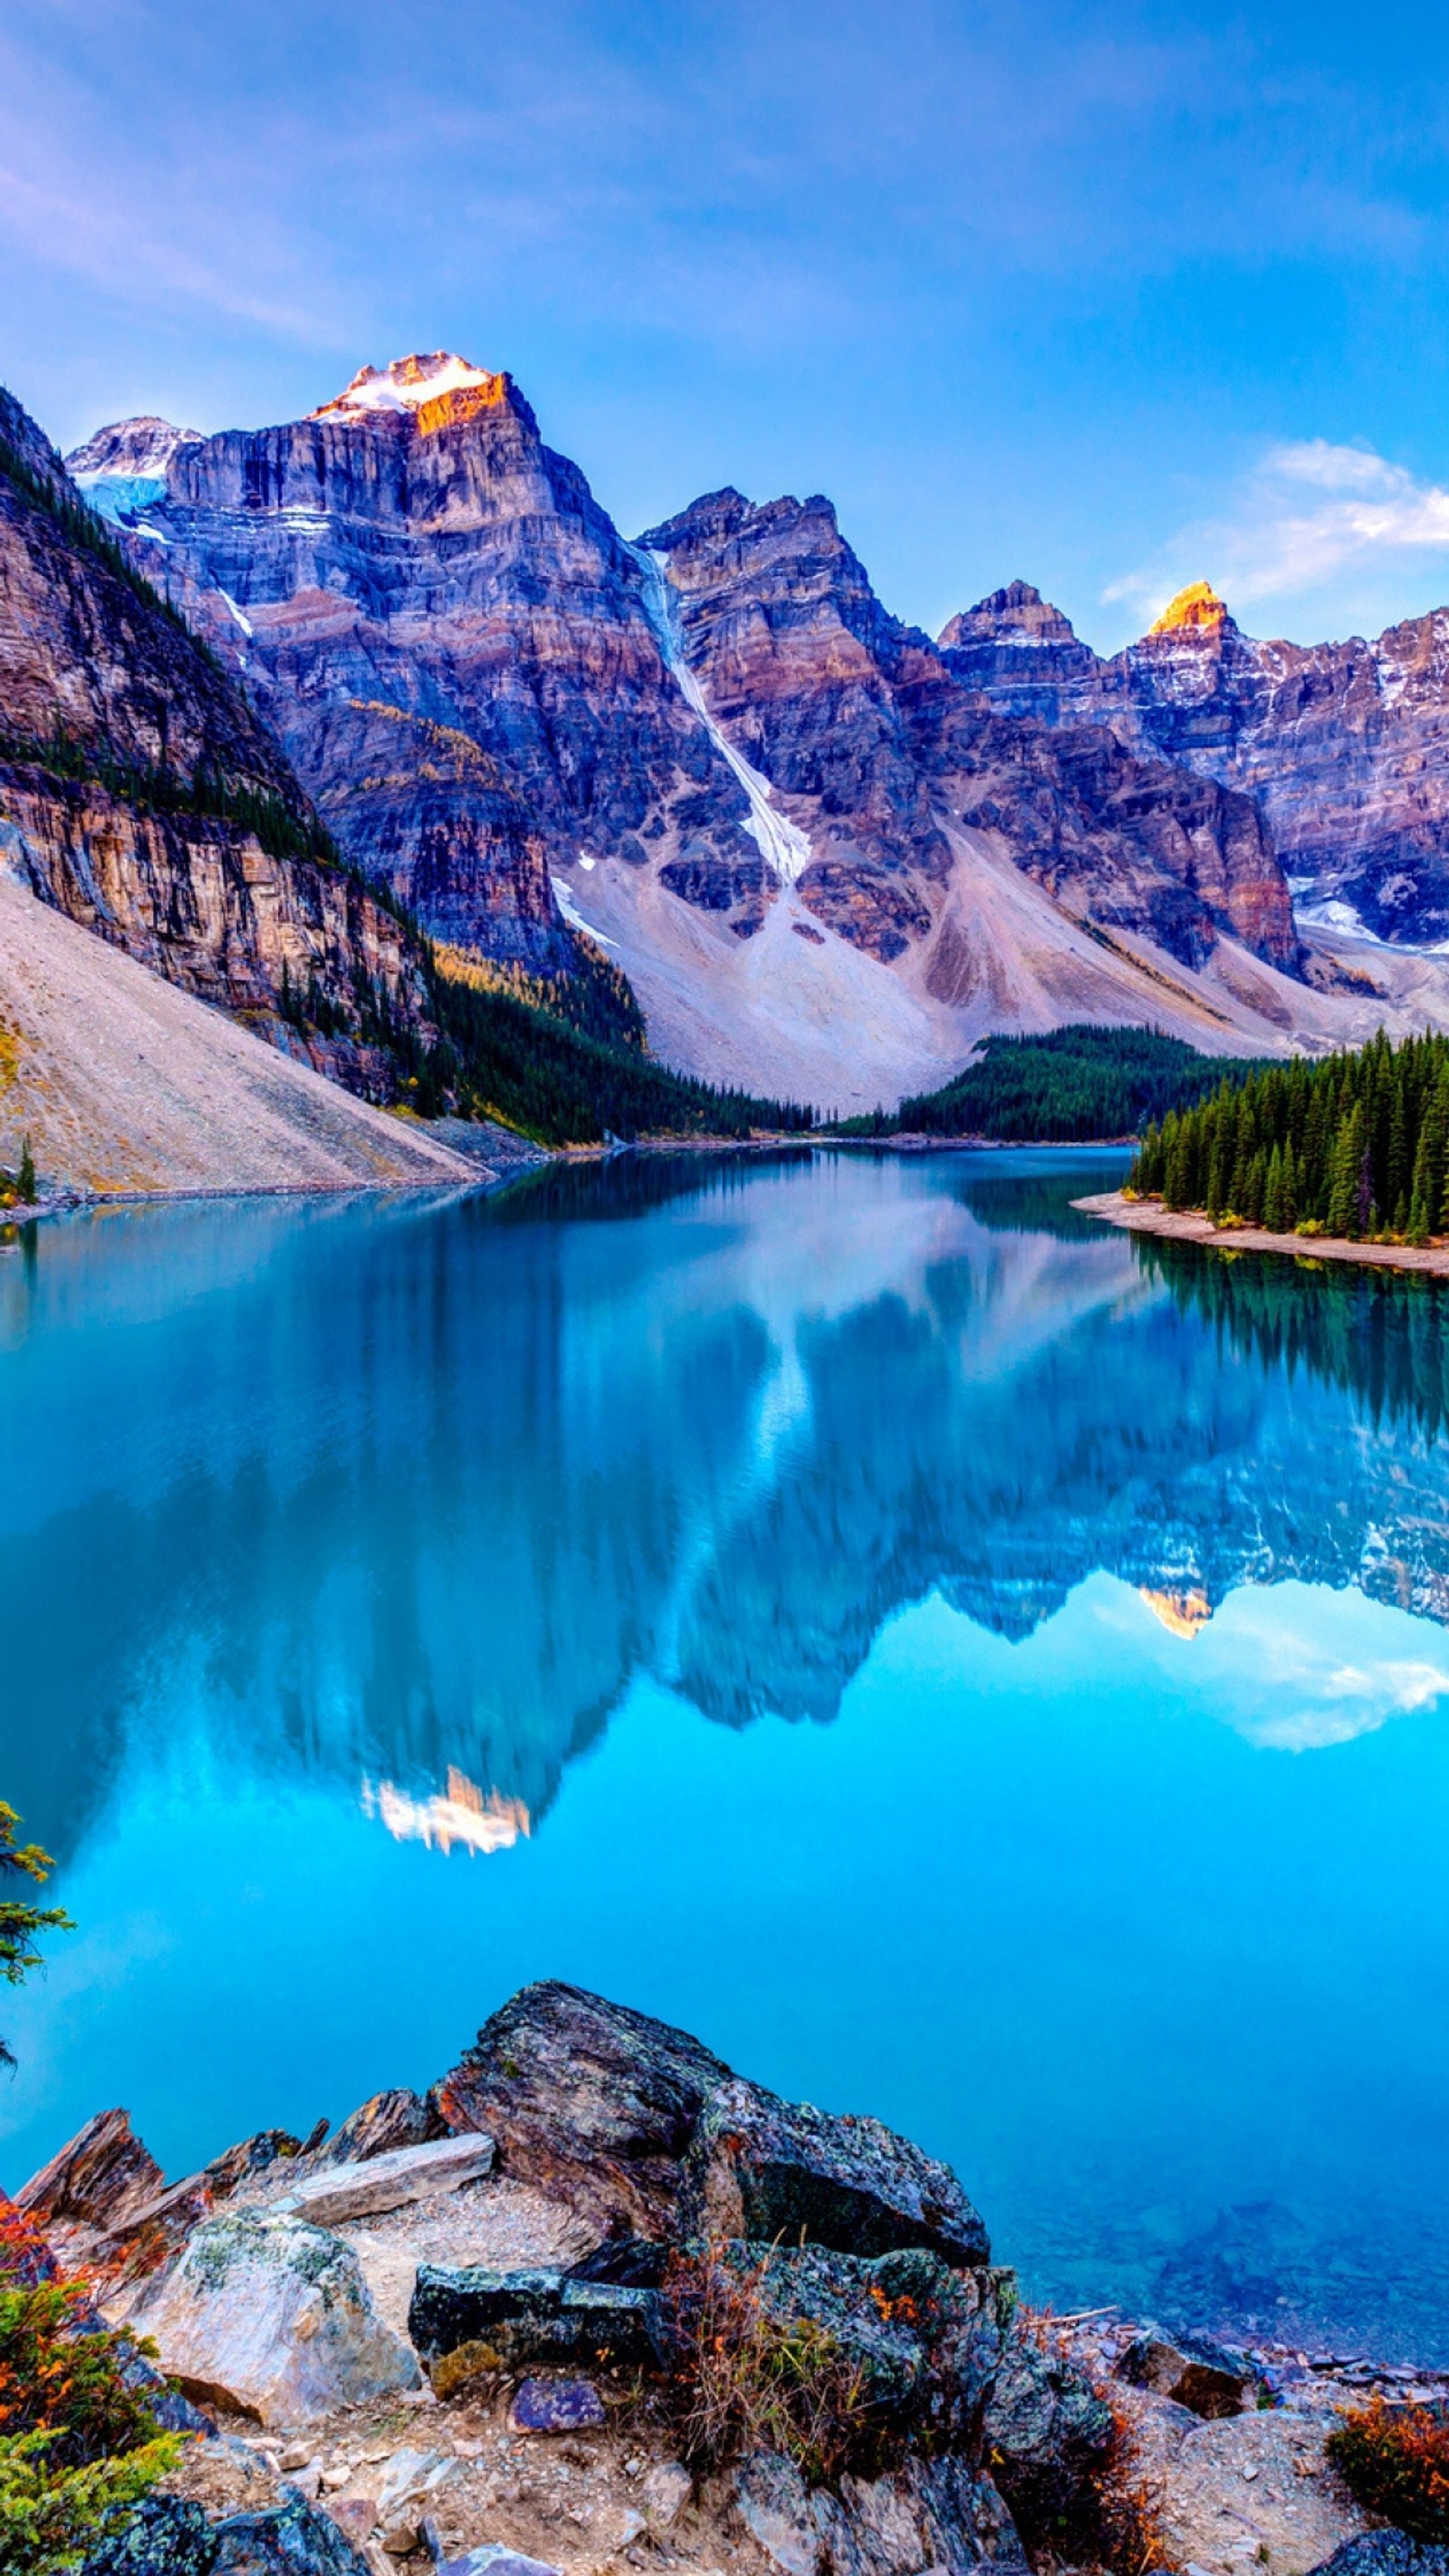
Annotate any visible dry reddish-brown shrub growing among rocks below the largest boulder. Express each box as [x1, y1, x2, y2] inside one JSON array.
[[664, 2244, 875, 2484]]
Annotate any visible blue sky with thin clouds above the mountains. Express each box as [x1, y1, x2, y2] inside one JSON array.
[[0, 0, 1449, 647]]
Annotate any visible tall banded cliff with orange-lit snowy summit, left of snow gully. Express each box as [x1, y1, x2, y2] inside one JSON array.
[[74, 355, 759, 968]]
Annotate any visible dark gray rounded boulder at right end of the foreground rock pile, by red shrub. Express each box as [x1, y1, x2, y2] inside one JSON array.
[[984, 2323, 1115, 2558]]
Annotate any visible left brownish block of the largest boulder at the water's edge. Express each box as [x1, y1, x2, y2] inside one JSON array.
[[427, 1984, 728, 2236]]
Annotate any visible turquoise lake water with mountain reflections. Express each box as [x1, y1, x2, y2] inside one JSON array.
[[0, 1151, 1449, 2360]]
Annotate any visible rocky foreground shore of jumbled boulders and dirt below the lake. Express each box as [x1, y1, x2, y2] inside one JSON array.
[[15, 1984, 1449, 2576]]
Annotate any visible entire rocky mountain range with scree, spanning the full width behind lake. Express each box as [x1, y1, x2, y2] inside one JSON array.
[[0, 353, 1449, 1139]]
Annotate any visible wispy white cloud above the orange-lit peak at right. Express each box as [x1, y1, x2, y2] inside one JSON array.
[[1104, 437, 1449, 619]]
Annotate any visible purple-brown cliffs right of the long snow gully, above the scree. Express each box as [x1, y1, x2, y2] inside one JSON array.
[[641, 492, 1297, 968]]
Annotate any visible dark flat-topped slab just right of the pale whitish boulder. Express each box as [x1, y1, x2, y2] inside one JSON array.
[[407, 2264, 667, 2369]]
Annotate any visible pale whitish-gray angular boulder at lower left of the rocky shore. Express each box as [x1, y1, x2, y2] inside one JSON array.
[[134, 2210, 419, 2424]]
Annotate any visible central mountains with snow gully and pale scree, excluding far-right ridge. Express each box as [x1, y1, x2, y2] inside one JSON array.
[[53, 351, 1449, 1110]]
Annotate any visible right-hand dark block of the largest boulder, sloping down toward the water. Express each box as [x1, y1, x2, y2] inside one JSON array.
[[682, 2079, 991, 2264]]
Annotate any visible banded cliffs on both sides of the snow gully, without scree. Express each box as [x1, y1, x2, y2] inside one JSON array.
[[72, 353, 1294, 989]]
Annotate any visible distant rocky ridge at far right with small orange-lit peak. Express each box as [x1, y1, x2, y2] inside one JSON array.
[[942, 582, 1449, 946]]
